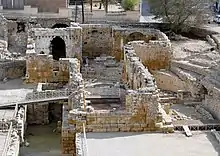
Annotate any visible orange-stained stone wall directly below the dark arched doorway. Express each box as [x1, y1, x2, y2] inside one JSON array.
[[26, 54, 69, 83]]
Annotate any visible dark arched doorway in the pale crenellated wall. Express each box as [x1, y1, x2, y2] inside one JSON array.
[[50, 36, 66, 61]]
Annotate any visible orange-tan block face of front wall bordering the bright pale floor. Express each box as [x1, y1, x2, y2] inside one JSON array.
[[76, 112, 159, 132]]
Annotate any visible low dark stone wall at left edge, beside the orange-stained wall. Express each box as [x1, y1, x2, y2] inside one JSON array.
[[0, 60, 26, 80]]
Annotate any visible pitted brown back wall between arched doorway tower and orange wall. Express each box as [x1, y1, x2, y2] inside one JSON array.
[[80, 24, 113, 57]]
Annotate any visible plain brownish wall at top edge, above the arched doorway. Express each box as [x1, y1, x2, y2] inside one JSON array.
[[25, 0, 67, 13]]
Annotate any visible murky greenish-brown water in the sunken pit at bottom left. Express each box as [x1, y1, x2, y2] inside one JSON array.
[[20, 124, 61, 156]]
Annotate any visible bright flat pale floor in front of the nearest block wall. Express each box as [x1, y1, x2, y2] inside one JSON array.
[[87, 132, 220, 156]]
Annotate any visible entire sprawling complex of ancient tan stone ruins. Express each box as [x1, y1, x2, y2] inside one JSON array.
[[0, 12, 220, 156]]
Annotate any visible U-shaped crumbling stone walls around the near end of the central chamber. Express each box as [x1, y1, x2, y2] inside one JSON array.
[[62, 44, 174, 155]]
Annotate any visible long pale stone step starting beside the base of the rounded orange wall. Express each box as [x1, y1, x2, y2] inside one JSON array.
[[171, 60, 211, 75]]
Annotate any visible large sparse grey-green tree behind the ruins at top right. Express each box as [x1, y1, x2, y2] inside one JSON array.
[[148, 0, 212, 32]]
